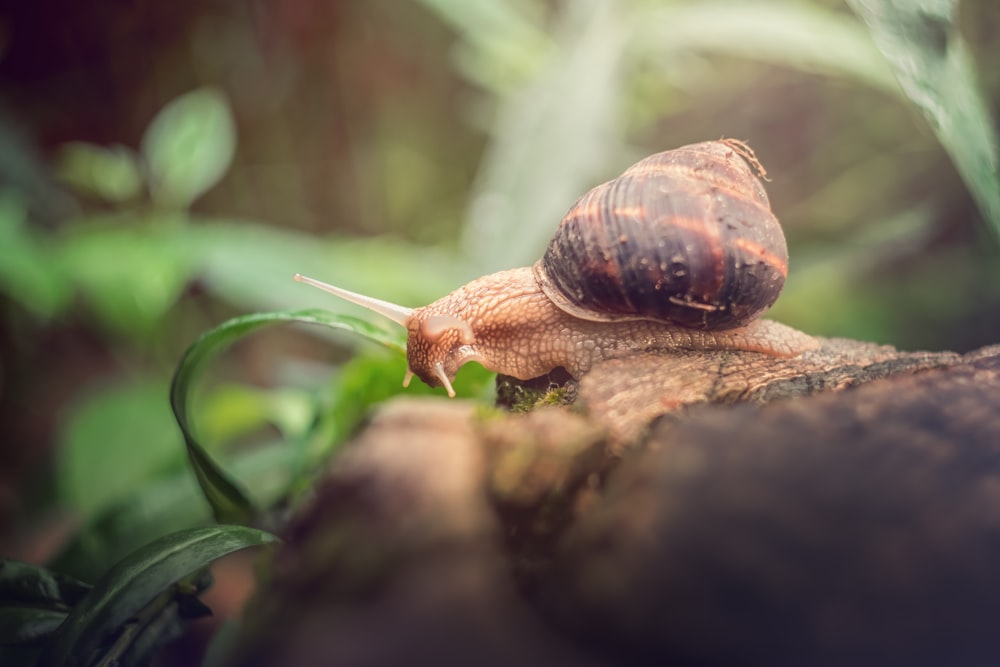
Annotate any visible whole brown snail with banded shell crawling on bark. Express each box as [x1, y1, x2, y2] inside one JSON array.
[[295, 139, 817, 396]]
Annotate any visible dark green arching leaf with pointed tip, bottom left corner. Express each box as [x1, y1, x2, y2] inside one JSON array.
[[39, 526, 277, 667]]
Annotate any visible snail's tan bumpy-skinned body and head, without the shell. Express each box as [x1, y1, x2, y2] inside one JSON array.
[[406, 267, 818, 387]]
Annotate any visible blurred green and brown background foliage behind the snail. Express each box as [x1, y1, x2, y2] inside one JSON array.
[[0, 0, 1000, 664]]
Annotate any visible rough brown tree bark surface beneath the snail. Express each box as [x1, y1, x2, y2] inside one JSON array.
[[231, 340, 1000, 666]]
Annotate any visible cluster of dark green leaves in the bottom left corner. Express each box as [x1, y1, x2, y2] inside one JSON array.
[[0, 525, 276, 667]]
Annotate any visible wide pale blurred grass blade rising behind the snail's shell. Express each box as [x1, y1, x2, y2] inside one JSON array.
[[462, 0, 629, 273]]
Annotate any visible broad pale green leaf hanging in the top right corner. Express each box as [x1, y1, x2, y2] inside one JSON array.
[[848, 0, 1000, 238]]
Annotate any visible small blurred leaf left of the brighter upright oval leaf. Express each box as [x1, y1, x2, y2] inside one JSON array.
[[56, 141, 142, 202]]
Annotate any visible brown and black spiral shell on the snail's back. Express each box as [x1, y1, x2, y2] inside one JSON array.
[[534, 140, 788, 329]]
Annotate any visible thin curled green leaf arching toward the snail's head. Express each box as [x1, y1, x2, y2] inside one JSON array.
[[170, 310, 402, 522]]
